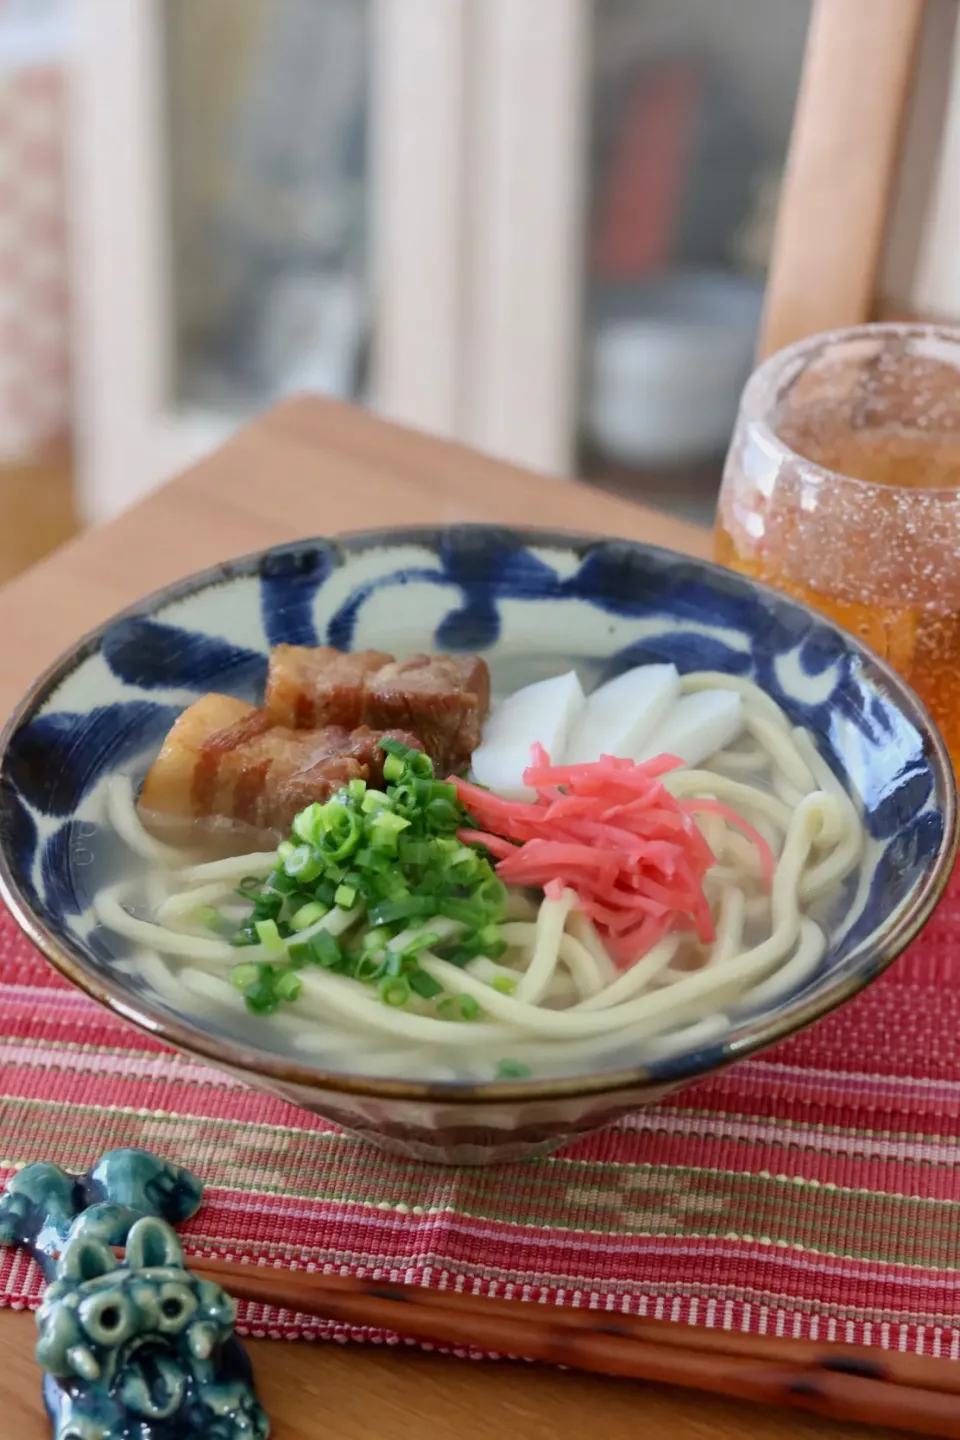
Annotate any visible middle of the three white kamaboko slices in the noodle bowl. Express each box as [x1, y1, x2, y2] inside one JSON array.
[[563, 665, 679, 765]]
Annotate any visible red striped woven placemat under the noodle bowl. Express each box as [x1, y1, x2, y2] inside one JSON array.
[[0, 878, 960, 1358]]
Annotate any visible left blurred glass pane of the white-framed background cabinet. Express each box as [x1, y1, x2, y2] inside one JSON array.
[[163, 0, 371, 416]]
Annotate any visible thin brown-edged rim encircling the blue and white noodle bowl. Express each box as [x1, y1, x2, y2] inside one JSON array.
[[0, 521, 960, 1109]]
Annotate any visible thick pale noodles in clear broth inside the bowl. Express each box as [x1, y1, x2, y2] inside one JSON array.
[[95, 672, 864, 1080]]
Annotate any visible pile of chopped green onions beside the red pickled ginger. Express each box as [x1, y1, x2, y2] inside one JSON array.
[[231, 740, 510, 1021]]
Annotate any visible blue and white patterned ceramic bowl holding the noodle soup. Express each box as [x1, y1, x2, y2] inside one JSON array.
[[0, 526, 957, 1162]]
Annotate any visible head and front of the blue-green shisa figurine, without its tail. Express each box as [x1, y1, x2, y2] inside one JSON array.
[[36, 1217, 269, 1440]]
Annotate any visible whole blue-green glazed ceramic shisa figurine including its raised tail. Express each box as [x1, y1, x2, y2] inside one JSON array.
[[0, 1149, 269, 1440]]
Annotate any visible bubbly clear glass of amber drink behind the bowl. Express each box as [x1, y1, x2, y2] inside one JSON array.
[[717, 325, 960, 773]]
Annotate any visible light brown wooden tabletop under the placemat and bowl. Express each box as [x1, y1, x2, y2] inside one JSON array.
[[0, 399, 903, 1440]]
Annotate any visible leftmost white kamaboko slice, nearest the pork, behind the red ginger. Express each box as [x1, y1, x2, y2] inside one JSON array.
[[472, 670, 584, 796]]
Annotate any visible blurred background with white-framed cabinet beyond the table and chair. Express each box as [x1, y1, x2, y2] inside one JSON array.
[[0, 0, 960, 577]]
